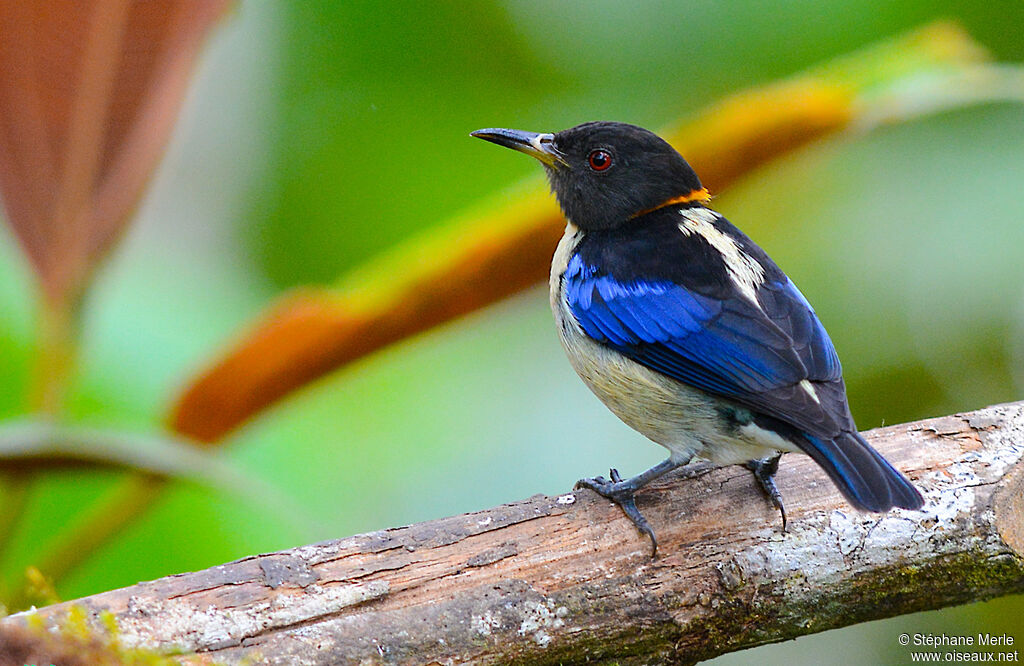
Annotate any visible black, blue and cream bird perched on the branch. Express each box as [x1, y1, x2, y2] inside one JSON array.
[[472, 122, 924, 553]]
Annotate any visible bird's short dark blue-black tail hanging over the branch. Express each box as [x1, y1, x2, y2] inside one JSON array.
[[802, 431, 925, 512]]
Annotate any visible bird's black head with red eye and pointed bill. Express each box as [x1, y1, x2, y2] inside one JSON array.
[[472, 122, 708, 231]]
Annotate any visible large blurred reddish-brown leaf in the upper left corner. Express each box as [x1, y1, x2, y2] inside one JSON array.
[[0, 0, 227, 300]]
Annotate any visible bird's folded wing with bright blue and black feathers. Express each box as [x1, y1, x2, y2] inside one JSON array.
[[563, 254, 855, 436]]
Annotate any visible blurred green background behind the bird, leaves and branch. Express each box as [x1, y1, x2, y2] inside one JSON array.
[[0, 0, 1024, 664]]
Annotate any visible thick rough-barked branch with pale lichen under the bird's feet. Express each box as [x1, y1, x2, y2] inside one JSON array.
[[0, 403, 1024, 664]]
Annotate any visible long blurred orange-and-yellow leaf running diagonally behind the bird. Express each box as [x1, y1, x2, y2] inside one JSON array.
[[169, 22, 1024, 445]]
